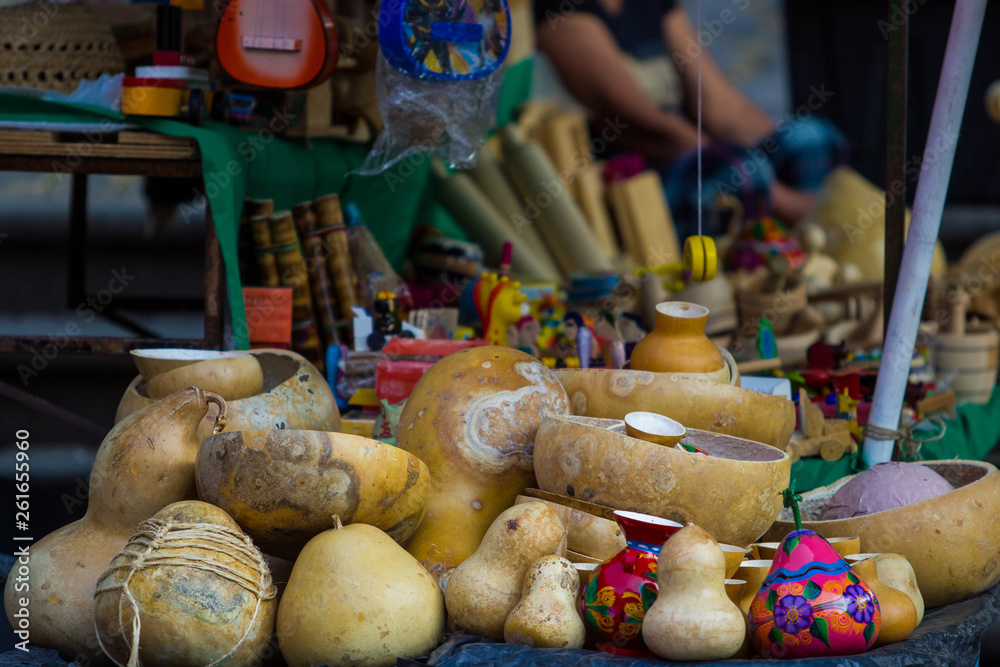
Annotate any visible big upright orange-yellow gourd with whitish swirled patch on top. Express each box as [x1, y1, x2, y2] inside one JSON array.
[[396, 347, 569, 580]]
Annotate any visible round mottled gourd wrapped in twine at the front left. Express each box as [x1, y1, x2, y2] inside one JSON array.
[[94, 501, 277, 667]]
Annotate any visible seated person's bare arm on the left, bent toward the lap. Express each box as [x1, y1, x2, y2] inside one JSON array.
[[537, 12, 697, 161]]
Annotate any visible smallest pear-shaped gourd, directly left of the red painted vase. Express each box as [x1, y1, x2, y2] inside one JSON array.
[[503, 555, 587, 648]]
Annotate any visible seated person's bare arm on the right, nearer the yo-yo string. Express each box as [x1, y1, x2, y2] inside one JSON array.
[[663, 8, 774, 146]]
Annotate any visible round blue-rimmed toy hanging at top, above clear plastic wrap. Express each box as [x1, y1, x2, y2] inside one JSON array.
[[379, 0, 510, 81]]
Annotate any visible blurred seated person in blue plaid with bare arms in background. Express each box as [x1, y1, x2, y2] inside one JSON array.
[[534, 0, 847, 239]]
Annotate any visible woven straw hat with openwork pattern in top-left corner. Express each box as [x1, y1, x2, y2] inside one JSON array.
[[0, 1, 125, 93]]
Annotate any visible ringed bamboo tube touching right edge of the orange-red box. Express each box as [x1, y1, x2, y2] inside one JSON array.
[[267, 211, 323, 372]]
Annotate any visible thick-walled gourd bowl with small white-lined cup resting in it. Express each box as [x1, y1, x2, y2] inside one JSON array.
[[534, 416, 791, 547]]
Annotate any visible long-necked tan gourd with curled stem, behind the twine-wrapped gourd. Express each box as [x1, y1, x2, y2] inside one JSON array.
[[4, 387, 225, 662]]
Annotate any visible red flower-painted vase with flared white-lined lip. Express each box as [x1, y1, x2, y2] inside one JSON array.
[[580, 511, 683, 657]]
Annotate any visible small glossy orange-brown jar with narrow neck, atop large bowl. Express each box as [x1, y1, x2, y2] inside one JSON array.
[[629, 301, 726, 373]]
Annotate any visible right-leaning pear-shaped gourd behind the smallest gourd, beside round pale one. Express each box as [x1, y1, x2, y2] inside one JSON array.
[[445, 503, 566, 641]]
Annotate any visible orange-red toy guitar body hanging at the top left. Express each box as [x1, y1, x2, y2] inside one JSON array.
[[215, 0, 338, 88]]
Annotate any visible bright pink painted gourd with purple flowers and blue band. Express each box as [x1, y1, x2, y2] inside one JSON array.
[[749, 530, 881, 659]]
